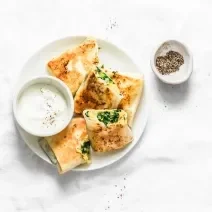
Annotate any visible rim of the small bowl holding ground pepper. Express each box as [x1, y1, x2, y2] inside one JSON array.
[[150, 39, 193, 85]]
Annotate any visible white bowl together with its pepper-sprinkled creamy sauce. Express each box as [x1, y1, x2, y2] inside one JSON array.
[[13, 76, 74, 137]]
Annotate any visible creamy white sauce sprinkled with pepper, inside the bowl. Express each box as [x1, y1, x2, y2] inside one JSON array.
[[17, 84, 68, 132]]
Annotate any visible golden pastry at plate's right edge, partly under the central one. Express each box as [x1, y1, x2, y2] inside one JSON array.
[[106, 71, 144, 126]]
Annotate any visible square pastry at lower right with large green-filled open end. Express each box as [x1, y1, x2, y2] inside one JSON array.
[[83, 109, 133, 152]]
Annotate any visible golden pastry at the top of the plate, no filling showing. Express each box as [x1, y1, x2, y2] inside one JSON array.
[[47, 38, 99, 95]]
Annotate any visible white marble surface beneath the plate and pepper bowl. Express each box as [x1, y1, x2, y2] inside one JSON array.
[[0, 0, 212, 212]]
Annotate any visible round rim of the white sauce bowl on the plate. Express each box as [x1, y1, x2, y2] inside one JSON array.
[[13, 76, 74, 137]]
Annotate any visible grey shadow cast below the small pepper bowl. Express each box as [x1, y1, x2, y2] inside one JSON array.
[[155, 77, 190, 105]]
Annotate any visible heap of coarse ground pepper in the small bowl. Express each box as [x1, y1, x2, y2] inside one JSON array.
[[156, 51, 184, 75]]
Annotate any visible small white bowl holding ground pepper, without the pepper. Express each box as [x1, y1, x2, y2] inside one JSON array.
[[150, 40, 193, 84]]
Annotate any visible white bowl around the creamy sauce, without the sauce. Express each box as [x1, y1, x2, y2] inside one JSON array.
[[13, 76, 74, 137]]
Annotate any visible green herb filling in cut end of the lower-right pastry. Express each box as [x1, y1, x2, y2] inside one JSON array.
[[97, 110, 121, 126]]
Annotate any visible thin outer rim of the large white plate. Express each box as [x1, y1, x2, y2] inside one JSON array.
[[13, 35, 150, 172]]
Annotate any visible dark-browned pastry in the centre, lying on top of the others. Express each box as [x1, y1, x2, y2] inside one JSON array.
[[74, 66, 122, 114]]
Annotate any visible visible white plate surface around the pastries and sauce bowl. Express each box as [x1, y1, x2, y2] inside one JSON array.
[[15, 36, 148, 171]]
